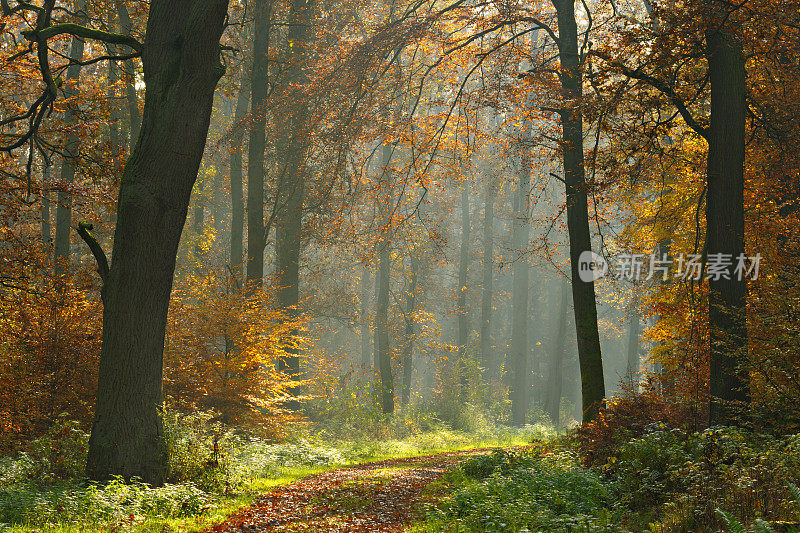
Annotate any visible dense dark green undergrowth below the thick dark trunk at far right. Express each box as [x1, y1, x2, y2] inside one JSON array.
[[599, 426, 800, 531]]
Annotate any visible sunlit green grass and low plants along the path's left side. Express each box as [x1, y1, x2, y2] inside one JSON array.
[[0, 427, 547, 533]]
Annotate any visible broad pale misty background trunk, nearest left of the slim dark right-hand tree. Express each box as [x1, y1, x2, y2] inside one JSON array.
[[509, 161, 531, 426]]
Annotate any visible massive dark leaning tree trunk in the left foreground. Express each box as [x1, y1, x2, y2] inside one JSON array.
[[87, 0, 228, 484]]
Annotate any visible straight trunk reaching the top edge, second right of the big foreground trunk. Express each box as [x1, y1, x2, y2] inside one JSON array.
[[247, 0, 272, 290]]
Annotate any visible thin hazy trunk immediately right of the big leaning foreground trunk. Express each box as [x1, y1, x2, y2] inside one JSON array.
[[230, 82, 250, 287]]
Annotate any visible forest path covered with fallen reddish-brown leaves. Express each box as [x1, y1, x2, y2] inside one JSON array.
[[200, 448, 497, 533]]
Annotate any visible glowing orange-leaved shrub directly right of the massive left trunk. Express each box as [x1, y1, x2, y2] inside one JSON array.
[[164, 271, 303, 435]]
